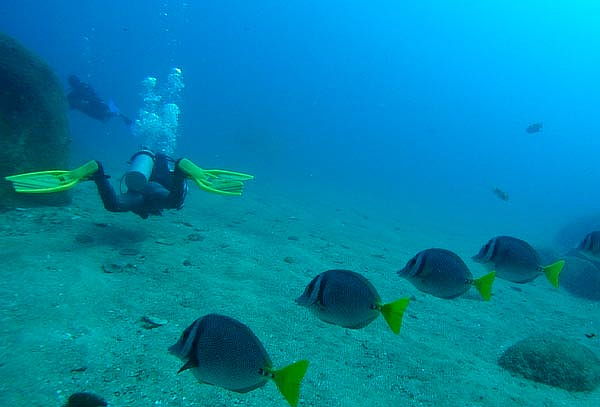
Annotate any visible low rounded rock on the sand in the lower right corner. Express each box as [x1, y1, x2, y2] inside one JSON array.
[[498, 335, 600, 391]]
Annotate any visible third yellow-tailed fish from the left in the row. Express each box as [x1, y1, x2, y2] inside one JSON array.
[[398, 248, 496, 301]]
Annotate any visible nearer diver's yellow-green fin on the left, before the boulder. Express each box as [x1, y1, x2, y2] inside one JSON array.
[[5, 160, 98, 194]]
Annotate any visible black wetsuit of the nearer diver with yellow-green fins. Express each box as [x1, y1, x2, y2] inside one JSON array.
[[91, 153, 187, 219]]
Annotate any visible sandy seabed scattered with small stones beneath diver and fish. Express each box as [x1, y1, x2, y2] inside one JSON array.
[[0, 184, 600, 407]]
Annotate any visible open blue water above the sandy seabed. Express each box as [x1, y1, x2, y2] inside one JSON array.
[[0, 0, 600, 406]]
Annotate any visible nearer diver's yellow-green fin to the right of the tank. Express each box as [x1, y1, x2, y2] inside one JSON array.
[[177, 158, 254, 195]]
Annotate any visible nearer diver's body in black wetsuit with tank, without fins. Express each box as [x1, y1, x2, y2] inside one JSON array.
[[90, 150, 187, 219]]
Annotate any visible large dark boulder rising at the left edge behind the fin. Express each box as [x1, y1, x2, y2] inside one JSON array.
[[0, 33, 70, 206]]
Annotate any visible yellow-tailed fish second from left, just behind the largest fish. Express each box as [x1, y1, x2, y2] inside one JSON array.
[[296, 270, 410, 334]]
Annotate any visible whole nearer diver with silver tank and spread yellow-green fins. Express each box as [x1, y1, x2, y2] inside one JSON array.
[[5, 148, 254, 219]]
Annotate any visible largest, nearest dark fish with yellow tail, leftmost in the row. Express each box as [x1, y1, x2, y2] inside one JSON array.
[[169, 314, 309, 407]]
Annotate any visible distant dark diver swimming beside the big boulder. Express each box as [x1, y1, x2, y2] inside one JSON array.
[[67, 75, 133, 126]]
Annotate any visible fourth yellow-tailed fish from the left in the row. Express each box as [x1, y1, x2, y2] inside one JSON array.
[[473, 236, 565, 288]]
